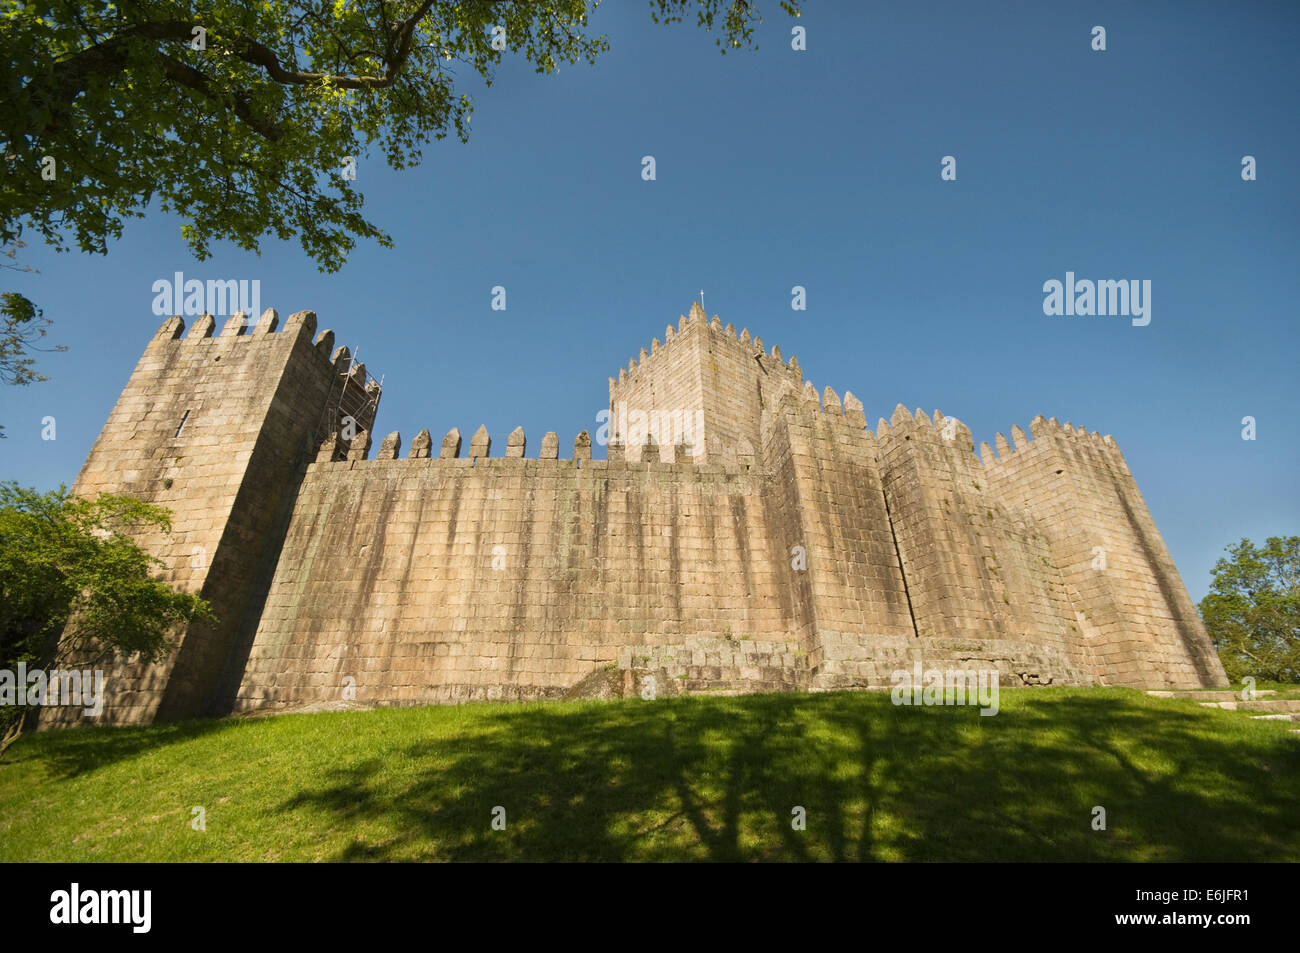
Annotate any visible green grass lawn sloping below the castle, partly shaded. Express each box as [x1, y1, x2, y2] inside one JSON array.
[[0, 688, 1300, 861]]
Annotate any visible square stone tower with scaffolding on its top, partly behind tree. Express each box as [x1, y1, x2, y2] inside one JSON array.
[[43, 309, 380, 722]]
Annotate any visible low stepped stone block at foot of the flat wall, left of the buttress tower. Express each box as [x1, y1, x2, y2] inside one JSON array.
[[619, 637, 809, 697]]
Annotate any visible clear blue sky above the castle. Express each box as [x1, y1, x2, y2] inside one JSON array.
[[0, 0, 1300, 599]]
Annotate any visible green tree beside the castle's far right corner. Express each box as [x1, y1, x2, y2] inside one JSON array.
[[1200, 536, 1300, 683]]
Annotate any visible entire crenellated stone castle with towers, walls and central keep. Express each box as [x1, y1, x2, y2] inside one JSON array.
[[50, 303, 1227, 724]]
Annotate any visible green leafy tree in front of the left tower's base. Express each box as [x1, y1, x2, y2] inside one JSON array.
[[0, 482, 212, 740]]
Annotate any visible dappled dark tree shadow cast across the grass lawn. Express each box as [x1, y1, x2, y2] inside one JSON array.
[[281, 692, 1300, 862]]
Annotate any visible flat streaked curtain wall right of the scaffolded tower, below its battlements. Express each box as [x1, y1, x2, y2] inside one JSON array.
[[238, 439, 802, 709]]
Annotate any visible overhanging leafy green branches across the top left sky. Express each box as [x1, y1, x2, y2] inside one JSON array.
[[0, 0, 798, 270]]
